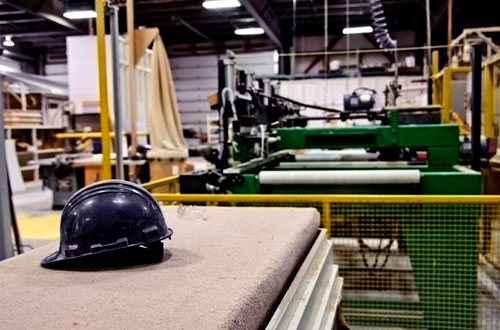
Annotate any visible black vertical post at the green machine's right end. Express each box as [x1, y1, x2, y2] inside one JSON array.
[[471, 44, 483, 171]]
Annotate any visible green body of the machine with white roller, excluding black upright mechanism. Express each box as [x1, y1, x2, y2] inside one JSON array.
[[223, 111, 481, 195]]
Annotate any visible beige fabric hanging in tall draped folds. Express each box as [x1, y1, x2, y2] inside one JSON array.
[[147, 34, 188, 159]]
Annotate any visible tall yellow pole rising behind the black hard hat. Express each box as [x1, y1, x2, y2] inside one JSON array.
[[95, 0, 111, 180]]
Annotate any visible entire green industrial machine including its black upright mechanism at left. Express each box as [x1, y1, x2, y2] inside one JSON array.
[[180, 54, 481, 195]]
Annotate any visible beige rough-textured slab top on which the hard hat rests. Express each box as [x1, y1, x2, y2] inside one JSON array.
[[0, 207, 319, 330]]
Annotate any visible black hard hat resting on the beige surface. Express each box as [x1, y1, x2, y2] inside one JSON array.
[[41, 180, 173, 268]]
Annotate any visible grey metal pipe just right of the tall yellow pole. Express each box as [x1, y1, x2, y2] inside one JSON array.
[[109, 6, 124, 180]]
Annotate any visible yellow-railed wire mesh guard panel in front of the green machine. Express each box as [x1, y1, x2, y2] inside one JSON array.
[[156, 194, 500, 329]]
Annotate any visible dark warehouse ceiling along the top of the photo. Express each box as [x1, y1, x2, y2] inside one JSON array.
[[0, 0, 500, 61]]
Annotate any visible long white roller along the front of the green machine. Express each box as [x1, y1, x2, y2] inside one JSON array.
[[259, 170, 420, 185]]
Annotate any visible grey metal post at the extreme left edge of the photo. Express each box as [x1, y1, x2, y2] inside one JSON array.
[[0, 74, 14, 260]]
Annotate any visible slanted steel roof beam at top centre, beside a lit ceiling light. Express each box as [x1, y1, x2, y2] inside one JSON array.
[[240, 0, 283, 49]]
